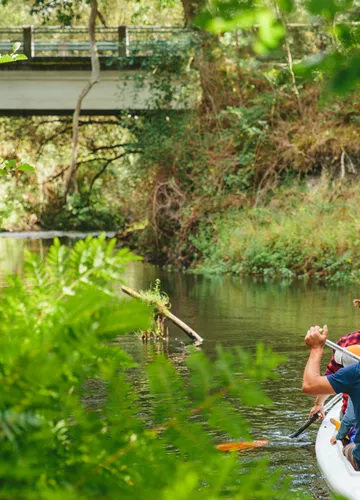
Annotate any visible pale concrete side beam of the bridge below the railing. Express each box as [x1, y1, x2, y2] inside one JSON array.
[[0, 64, 199, 116]]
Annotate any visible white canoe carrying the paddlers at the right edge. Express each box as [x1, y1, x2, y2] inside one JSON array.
[[315, 401, 360, 500]]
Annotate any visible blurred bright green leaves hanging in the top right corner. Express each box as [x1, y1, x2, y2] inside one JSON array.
[[196, 0, 360, 94]]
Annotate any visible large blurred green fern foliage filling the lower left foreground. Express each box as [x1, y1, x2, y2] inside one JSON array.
[[0, 237, 306, 500]]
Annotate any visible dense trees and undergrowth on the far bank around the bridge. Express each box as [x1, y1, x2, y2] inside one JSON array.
[[0, 0, 360, 282]]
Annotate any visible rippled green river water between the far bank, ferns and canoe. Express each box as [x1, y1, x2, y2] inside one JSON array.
[[0, 237, 360, 499]]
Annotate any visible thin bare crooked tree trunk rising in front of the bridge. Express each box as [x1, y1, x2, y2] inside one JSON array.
[[64, 0, 100, 203]]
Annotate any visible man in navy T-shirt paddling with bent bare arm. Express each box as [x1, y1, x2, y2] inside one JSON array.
[[302, 326, 360, 471]]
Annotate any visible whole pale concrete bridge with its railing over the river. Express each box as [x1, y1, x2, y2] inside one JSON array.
[[0, 26, 200, 116]]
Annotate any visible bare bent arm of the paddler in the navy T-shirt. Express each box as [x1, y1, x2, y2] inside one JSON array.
[[302, 326, 335, 396]]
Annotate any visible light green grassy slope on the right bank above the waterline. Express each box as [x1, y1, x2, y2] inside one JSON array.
[[193, 183, 360, 282]]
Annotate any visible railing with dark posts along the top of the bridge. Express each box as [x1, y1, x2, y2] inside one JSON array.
[[0, 26, 191, 59]]
